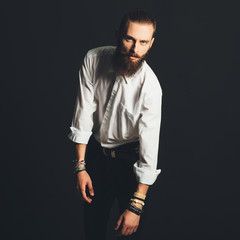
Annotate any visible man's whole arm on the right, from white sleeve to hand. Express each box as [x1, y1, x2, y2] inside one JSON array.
[[115, 77, 162, 236]]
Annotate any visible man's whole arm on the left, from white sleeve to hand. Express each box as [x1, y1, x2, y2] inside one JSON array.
[[68, 51, 96, 203]]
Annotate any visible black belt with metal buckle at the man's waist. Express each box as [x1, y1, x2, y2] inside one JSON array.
[[101, 141, 139, 158]]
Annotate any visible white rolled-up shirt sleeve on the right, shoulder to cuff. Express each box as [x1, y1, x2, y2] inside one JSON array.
[[133, 79, 162, 185]]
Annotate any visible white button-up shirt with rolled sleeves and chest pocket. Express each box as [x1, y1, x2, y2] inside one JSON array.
[[69, 47, 162, 185]]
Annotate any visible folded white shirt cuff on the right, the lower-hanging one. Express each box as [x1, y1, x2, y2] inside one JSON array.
[[133, 162, 161, 185]]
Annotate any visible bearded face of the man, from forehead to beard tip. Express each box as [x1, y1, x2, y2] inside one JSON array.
[[115, 21, 154, 76]]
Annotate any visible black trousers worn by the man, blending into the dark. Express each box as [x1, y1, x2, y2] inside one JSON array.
[[84, 139, 143, 240]]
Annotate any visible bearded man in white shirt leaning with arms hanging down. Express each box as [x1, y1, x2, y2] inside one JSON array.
[[69, 10, 161, 240]]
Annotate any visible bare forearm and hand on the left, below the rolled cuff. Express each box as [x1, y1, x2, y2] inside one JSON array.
[[76, 143, 94, 203]]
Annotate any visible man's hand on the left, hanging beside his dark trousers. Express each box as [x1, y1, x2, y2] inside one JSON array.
[[77, 171, 94, 203]]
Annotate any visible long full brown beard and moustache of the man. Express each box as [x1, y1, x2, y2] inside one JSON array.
[[113, 45, 148, 77]]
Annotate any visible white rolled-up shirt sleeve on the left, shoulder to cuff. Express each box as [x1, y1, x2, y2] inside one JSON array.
[[68, 51, 96, 144]]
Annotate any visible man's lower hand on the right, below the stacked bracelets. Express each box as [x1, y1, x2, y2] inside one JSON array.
[[115, 209, 140, 236]]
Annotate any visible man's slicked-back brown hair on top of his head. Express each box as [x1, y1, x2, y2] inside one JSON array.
[[119, 9, 157, 37]]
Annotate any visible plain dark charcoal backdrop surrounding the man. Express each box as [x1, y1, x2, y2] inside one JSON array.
[[0, 0, 240, 240]]
